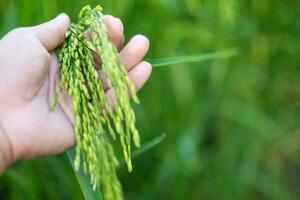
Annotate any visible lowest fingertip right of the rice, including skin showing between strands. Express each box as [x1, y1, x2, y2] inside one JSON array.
[[106, 61, 152, 107]]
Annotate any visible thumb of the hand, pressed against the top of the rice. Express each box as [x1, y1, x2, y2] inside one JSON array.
[[30, 13, 70, 52]]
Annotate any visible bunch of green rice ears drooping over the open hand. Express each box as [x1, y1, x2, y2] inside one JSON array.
[[51, 6, 140, 200]]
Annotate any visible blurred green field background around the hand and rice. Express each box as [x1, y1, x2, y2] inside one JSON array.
[[0, 0, 300, 200]]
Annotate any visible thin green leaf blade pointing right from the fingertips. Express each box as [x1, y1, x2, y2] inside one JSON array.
[[148, 48, 239, 67]]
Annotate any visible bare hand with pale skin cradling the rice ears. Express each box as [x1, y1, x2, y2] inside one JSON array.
[[0, 14, 152, 173]]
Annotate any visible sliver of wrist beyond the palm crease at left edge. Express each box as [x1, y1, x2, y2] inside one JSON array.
[[0, 123, 12, 174]]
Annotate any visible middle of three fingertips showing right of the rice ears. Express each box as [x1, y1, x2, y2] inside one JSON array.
[[120, 35, 150, 71]]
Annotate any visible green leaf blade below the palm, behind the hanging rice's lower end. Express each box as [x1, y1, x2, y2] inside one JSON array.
[[67, 149, 103, 200]]
